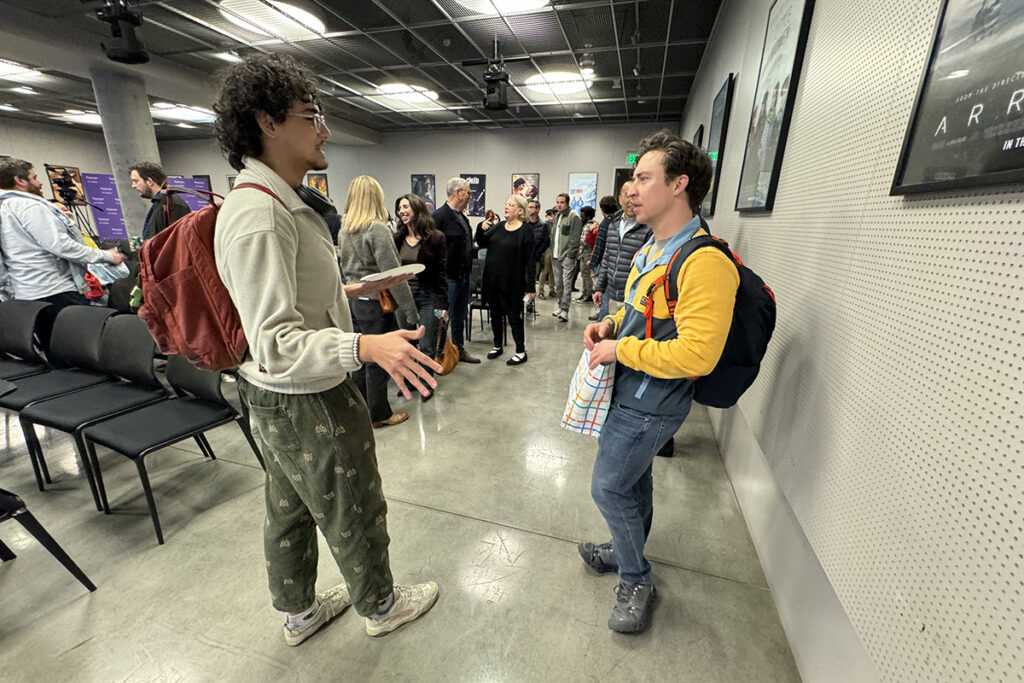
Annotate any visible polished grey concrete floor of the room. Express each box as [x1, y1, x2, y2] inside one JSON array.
[[0, 301, 799, 682]]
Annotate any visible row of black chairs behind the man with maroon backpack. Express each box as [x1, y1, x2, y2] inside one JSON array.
[[0, 301, 263, 544]]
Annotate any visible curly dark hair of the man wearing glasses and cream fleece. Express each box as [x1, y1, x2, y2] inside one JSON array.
[[213, 54, 319, 171]]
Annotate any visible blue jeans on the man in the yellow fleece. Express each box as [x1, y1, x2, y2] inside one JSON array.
[[590, 402, 690, 584]]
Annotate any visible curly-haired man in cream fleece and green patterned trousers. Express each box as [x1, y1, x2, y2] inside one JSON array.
[[214, 54, 441, 645]]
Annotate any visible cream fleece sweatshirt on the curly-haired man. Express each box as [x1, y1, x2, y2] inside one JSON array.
[[213, 157, 360, 393]]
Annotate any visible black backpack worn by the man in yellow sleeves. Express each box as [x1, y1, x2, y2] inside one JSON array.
[[647, 234, 775, 408]]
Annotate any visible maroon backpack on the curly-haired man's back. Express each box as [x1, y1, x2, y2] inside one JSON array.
[[138, 182, 285, 370]]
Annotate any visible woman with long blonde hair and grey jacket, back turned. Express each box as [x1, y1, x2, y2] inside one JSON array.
[[338, 175, 420, 428]]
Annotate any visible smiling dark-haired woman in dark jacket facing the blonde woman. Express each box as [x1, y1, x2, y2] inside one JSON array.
[[394, 194, 447, 402]]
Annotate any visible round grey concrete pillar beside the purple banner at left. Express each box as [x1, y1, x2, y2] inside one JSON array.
[[89, 67, 160, 237]]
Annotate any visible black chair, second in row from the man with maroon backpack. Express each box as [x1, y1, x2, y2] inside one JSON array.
[[18, 315, 169, 510]]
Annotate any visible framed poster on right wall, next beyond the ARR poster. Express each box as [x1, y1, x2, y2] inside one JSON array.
[[736, 0, 814, 211]]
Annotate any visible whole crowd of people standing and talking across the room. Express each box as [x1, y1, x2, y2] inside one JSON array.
[[0, 54, 738, 645]]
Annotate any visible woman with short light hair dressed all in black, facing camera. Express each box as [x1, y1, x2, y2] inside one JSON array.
[[476, 195, 535, 366]]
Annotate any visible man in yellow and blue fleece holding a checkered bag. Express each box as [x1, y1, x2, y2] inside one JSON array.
[[579, 130, 739, 633]]
